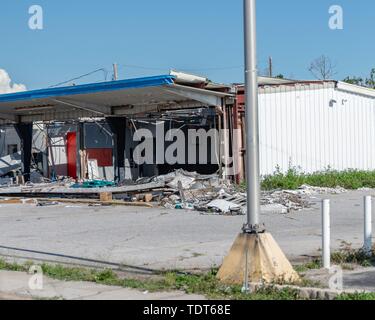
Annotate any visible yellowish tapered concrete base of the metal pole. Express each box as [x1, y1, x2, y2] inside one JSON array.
[[217, 232, 301, 285]]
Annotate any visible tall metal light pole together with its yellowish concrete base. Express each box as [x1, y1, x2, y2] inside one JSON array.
[[217, 0, 300, 289]]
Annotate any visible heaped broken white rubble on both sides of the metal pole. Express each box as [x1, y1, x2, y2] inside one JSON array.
[[153, 170, 347, 215]]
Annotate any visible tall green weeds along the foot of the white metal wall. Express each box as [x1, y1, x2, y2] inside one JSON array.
[[258, 168, 375, 190]]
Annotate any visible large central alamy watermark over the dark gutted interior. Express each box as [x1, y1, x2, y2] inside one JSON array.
[[132, 122, 241, 176]]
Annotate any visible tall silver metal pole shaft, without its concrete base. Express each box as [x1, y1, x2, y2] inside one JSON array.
[[244, 0, 260, 233]]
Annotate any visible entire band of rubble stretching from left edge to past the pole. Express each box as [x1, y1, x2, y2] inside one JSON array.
[[0, 169, 347, 215]]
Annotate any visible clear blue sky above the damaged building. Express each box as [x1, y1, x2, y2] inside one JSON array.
[[0, 0, 375, 89]]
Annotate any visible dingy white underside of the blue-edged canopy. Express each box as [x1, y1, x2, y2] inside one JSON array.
[[0, 84, 230, 123]]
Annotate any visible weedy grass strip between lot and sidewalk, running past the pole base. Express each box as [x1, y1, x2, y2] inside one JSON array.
[[0, 259, 306, 300]]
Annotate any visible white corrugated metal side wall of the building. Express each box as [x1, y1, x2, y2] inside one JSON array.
[[259, 83, 375, 175]]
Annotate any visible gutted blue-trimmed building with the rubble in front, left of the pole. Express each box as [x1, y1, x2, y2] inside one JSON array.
[[0, 71, 266, 219]]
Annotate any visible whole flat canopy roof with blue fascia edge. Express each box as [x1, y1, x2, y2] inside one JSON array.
[[0, 75, 231, 123]]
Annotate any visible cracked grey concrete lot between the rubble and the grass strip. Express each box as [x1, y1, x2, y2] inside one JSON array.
[[0, 190, 375, 273]]
